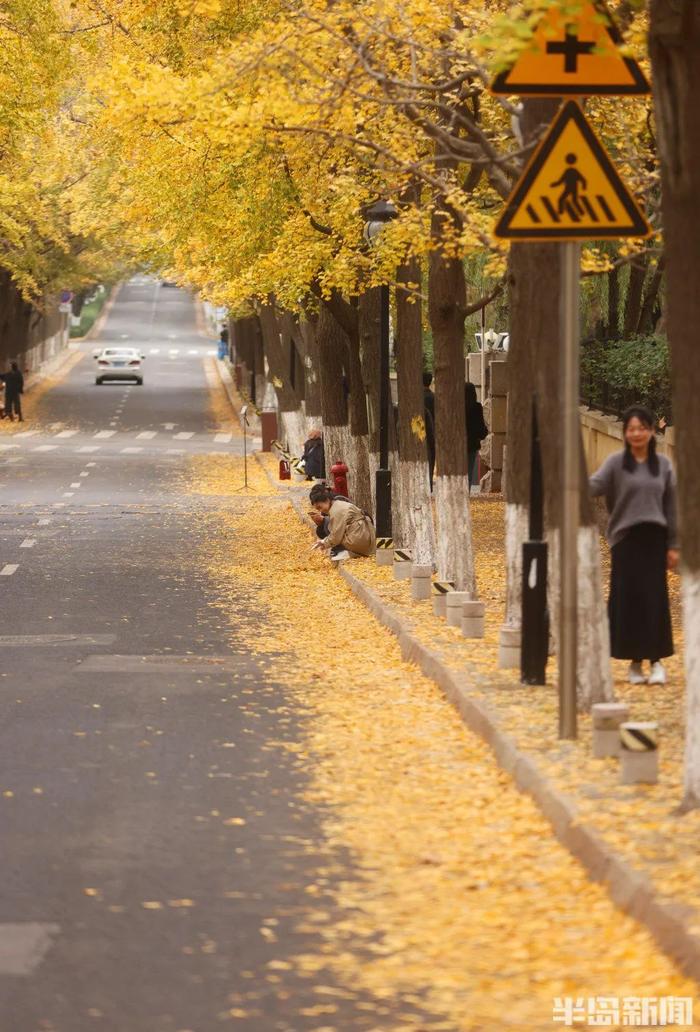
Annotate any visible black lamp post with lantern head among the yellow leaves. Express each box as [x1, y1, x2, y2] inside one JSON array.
[[364, 200, 399, 538]]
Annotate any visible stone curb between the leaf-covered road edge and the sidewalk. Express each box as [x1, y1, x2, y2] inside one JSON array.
[[256, 466, 700, 981]]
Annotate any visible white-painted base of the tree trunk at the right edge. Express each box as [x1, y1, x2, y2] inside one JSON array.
[[682, 570, 700, 809]]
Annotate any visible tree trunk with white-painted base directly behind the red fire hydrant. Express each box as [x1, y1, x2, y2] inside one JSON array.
[[316, 301, 354, 482]]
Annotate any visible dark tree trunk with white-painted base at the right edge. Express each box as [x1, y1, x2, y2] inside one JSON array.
[[649, 0, 700, 809]]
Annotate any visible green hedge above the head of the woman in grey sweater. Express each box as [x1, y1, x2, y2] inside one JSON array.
[[581, 336, 672, 423]]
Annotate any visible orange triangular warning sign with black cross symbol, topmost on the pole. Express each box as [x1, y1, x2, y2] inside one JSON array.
[[490, 0, 650, 97]]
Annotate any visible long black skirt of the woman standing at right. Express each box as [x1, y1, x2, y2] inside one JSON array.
[[608, 523, 673, 659]]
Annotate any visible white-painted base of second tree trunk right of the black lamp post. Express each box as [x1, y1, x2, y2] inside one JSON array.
[[435, 476, 477, 599]]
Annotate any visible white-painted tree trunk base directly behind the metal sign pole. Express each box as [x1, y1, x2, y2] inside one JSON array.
[[547, 526, 614, 712]]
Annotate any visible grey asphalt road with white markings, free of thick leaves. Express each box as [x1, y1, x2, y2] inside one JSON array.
[[0, 278, 417, 1032]]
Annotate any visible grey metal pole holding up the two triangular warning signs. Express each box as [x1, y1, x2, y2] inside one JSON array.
[[559, 243, 580, 738]]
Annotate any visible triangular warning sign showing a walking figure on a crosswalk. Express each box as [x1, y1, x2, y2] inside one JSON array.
[[495, 100, 651, 240]]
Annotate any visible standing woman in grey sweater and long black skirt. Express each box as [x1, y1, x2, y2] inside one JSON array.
[[590, 406, 678, 684]]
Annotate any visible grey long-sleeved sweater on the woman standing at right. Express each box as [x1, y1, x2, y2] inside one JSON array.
[[591, 451, 678, 548]]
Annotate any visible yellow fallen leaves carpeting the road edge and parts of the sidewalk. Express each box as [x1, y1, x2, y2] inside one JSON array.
[[183, 457, 695, 1032]]
